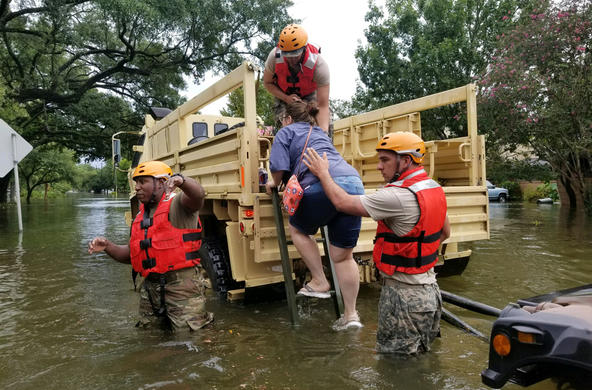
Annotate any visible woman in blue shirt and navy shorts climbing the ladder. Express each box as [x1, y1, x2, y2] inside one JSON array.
[[266, 101, 364, 330]]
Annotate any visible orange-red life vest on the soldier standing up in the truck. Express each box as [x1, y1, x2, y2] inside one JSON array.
[[275, 43, 320, 97]]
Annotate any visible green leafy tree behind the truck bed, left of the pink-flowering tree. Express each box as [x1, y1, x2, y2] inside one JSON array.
[[353, 0, 526, 139]]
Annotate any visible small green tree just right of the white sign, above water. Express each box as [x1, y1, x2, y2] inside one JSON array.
[[19, 144, 74, 203]]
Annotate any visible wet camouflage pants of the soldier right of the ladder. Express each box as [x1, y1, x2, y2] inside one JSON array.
[[376, 279, 442, 355]]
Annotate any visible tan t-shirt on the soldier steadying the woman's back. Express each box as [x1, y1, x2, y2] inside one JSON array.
[[360, 187, 436, 284]]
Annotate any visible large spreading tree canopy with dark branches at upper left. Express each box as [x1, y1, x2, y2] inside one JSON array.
[[0, 0, 291, 116]]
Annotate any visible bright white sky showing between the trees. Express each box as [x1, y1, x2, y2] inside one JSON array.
[[184, 0, 384, 114]]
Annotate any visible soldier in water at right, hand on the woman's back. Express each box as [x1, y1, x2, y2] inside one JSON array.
[[304, 132, 450, 355]]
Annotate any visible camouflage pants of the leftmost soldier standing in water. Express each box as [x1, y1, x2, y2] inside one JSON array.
[[136, 267, 214, 331]]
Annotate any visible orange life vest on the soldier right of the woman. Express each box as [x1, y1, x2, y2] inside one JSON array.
[[372, 167, 446, 275]]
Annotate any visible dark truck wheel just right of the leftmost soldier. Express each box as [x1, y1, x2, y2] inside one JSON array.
[[199, 238, 232, 297]]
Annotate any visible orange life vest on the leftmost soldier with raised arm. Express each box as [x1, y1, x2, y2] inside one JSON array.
[[130, 194, 202, 277]]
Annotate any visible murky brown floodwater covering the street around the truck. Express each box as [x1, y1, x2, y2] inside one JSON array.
[[0, 197, 592, 389]]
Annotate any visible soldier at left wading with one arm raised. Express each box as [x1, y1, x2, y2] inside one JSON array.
[[88, 161, 214, 331]]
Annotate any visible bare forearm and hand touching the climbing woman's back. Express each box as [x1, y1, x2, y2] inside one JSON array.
[[303, 148, 370, 217]]
